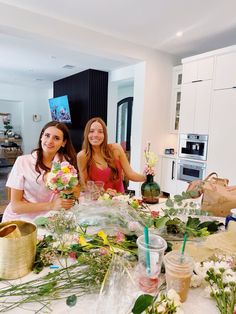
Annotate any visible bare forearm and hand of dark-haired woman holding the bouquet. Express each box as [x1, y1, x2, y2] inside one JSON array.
[[11, 188, 75, 214]]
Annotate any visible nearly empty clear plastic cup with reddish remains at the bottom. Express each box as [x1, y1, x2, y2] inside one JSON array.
[[137, 233, 167, 293]]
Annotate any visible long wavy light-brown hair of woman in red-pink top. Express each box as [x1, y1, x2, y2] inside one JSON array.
[[82, 117, 118, 181]]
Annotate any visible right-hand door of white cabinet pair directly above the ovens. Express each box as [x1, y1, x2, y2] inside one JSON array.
[[194, 80, 212, 134]]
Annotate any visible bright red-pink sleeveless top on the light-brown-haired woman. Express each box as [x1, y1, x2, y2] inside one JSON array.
[[88, 160, 125, 193]]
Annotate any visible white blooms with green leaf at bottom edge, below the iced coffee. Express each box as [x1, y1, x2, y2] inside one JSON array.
[[132, 289, 184, 314]]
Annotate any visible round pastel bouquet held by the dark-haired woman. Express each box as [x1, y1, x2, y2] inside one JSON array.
[[46, 161, 78, 198]]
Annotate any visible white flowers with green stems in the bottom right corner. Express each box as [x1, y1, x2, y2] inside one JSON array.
[[191, 256, 236, 314]]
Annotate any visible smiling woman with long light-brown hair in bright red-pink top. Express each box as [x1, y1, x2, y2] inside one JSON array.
[[77, 118, 146, 193]]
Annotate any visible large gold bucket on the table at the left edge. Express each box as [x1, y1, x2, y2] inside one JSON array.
[[0, 220, 37, 279]]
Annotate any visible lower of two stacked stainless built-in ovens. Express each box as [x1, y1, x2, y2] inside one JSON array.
[[177, 159, 206, 182]]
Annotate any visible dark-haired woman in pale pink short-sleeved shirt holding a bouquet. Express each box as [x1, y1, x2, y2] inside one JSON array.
[[2, 121, 77, 221]]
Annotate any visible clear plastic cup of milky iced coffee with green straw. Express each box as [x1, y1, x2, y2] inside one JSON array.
[[164, 251, 194, 302]]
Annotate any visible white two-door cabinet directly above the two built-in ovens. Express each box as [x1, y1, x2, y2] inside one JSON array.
[[180, 80, 212, 134]]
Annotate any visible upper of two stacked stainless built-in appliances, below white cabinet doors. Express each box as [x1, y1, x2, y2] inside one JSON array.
[[179, 134, 208, 160]]
